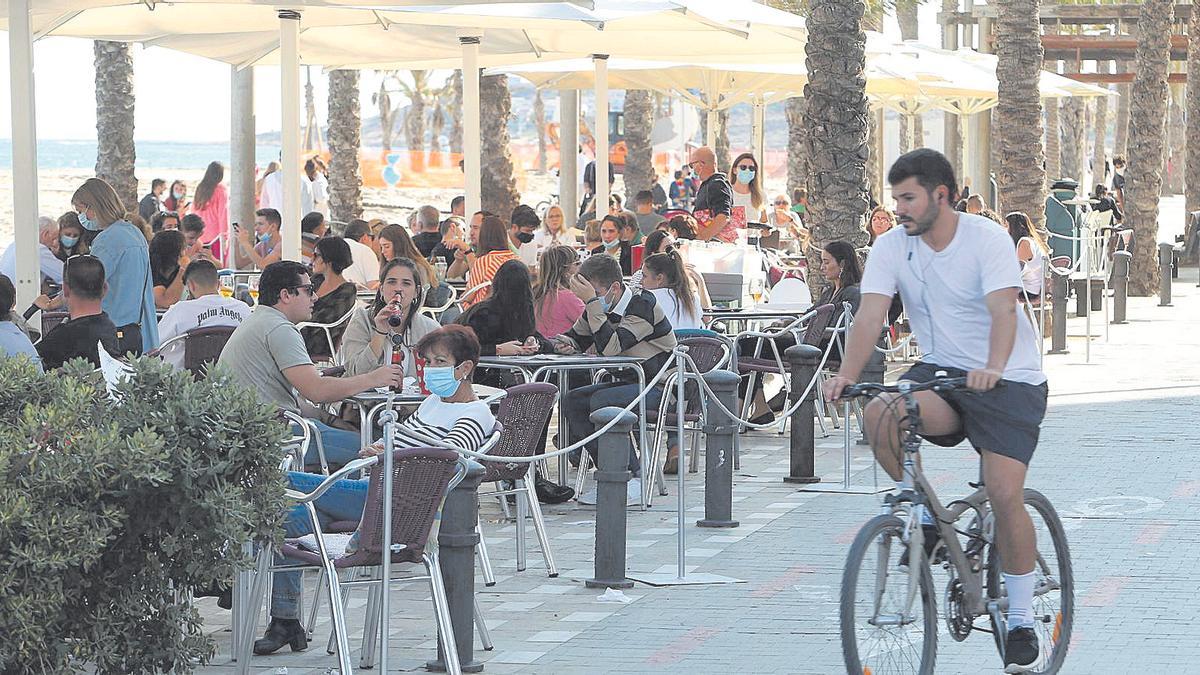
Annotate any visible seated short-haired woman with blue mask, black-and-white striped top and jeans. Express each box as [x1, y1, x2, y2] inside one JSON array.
[[254, 325, 496, 655]]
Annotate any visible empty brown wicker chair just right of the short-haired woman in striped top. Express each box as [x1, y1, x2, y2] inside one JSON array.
[[480, 382, 558, 583]]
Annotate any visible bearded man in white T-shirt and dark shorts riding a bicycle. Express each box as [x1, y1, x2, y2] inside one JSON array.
[[824, 148, 1048, 673]]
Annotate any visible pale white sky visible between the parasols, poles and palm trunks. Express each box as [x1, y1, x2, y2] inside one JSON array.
[[0, 2, 940, 143]]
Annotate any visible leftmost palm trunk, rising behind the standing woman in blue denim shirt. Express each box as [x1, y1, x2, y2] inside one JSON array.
[[94, 40, 138, 211]]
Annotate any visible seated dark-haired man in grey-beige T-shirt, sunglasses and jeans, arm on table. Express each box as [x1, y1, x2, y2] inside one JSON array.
[[225, 261, 404, 465]]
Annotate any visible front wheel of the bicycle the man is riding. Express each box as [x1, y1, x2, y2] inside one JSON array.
[[841, 515, 937, 675]]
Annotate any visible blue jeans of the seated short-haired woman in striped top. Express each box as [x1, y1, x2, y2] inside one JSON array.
[[271, 470, 371, 619]]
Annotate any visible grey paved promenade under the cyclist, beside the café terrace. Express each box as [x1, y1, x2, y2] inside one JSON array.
[[202, 264, 1200, 675]]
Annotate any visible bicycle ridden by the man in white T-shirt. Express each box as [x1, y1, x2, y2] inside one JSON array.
[[840, 377, 1074, 675]]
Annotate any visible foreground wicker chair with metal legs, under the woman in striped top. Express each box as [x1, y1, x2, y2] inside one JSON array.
[[240, 448, 466, 674]]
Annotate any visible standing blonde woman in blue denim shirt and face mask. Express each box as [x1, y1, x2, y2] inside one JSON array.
[[71, 178, 158, 354]]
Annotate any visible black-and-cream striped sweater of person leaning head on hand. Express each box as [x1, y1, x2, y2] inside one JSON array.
[[558, 286, 676, 380]]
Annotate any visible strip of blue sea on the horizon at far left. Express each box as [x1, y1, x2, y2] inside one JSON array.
[[0, 138, 280, 169]]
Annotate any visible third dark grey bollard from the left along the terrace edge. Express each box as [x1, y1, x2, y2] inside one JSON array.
[[692, 370, 738, 527]]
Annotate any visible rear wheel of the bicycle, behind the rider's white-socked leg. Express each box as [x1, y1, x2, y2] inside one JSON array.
[[988, 488, 1075, 674]]
